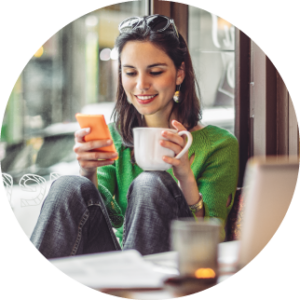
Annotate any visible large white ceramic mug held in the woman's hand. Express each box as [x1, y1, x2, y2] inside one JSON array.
[[133, 127, 193, 171]]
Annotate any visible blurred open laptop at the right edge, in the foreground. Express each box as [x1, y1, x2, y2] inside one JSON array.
[[237, 156, 300, 272]]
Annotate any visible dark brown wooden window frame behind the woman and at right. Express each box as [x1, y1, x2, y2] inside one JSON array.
[[154, 0, 300, 187]]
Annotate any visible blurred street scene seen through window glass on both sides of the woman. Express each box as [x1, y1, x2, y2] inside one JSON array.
[[0, 0, 235, 237]]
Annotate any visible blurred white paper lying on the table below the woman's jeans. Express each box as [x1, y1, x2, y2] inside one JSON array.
[[48, 250, 174, 288]]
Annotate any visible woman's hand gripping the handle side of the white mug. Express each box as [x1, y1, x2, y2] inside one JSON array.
[[160, 120, 192, 182]]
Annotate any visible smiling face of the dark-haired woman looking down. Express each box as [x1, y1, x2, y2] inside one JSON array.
[[120, 41, 184, 127]]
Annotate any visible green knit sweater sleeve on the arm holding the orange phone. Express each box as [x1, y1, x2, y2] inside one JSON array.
[[97, 124, 124, 228]]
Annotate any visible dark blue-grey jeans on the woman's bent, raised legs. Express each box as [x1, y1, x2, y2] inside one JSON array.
[[30, 171, 193, 259]]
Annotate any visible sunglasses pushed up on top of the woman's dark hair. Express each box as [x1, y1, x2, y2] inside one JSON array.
[[119, 15, 179, 39]]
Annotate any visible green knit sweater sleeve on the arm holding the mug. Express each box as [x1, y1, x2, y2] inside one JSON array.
[[197, 129, 239, 241]]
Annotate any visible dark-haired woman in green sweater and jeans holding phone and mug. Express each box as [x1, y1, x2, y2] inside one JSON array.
[[30, 15, 238, 258]]
